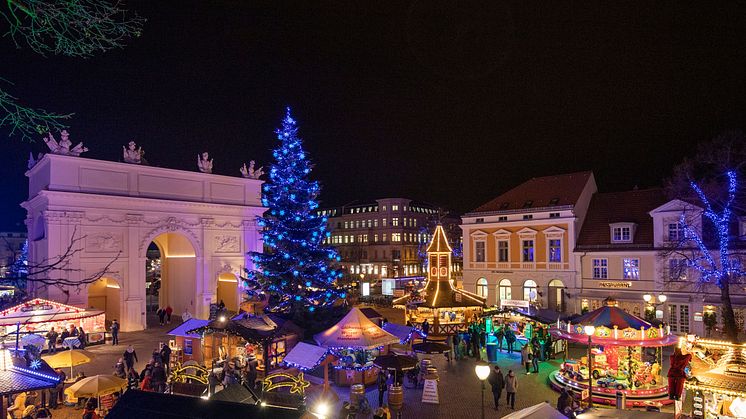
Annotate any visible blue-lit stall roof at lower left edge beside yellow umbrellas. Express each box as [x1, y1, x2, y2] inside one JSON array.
[[0, 350, 59, 396]]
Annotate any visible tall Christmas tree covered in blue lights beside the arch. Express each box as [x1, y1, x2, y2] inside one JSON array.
[[244, 108, 345, 318]]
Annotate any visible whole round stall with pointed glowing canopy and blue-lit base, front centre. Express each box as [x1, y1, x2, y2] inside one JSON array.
[[313, 308, 400, 386]]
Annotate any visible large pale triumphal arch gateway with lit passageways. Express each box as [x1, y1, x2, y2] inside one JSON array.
[[22, 154, 264, 331]]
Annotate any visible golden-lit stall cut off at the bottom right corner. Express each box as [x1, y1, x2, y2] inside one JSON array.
[[681, 335, 746, 419]]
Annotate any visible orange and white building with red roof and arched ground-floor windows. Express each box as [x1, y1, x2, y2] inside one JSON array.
[[461, 171, 597, 312]]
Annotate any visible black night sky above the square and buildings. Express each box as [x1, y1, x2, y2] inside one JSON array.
[[0, 0, 746, 228]]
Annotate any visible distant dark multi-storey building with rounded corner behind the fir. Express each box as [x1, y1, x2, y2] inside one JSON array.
[[319, 198, 461, 279]]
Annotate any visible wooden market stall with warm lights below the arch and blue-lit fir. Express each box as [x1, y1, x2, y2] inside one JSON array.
[[186, 313, 303, 379]]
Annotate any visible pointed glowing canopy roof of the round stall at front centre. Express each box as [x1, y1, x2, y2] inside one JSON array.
[[313, 307, 399, 349]]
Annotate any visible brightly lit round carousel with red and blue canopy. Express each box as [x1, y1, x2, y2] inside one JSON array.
[[549, 298, 678, 407]]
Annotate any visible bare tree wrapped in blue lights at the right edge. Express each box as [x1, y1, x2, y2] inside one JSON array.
[[664, 131, 746, 342]]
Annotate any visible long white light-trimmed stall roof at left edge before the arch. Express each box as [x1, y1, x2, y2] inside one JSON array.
[[0, 298, 104, 326]]
